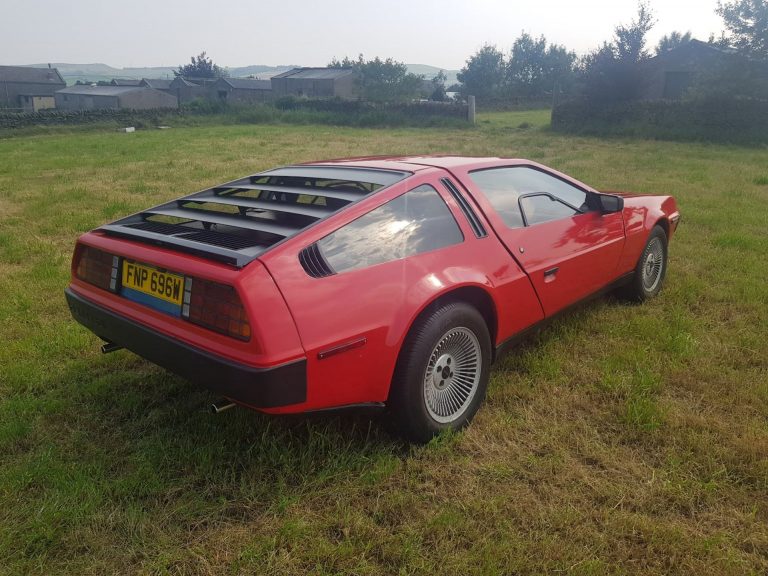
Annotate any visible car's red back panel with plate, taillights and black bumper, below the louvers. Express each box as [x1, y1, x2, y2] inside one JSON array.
[[66, 233, 306, 408]]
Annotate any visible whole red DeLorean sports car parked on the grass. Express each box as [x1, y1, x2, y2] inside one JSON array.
[[66, 156, 680, 441]]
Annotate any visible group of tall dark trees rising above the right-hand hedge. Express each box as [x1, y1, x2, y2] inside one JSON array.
[[458, 0, 768, 104]]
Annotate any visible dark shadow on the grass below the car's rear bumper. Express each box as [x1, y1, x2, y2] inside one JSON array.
[[54, 351, 410, 491]]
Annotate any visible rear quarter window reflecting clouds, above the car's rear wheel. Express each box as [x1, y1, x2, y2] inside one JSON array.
[[317, 184, 464, 272]]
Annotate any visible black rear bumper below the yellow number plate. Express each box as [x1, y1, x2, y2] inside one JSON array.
[[65, 288, 307, 408]]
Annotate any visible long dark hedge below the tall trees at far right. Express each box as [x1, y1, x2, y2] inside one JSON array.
[[552, 98, 768, 144]]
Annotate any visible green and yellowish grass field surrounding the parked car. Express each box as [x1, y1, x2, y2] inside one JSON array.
[[0, 112, 768, 575]]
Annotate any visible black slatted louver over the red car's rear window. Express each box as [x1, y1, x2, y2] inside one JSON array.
[[99, 166, 409, 268]]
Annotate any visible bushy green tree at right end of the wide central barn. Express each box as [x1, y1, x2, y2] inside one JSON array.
[[328, 54, 424, 102]]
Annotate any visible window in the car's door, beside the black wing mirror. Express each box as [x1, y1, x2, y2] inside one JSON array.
[[469, 166, 587, 228]]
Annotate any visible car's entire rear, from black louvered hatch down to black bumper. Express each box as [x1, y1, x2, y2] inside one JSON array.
[[66, 166, 407, 411]]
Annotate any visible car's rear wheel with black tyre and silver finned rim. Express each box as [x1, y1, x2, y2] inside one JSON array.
[[388, 302, 491, 443]]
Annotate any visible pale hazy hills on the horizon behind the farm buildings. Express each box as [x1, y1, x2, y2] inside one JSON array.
[[23, 62, 458, 86]]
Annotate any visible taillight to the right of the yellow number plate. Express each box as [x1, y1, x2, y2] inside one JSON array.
[[181, 277, 251, 340]]
